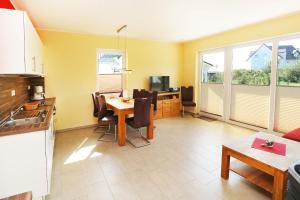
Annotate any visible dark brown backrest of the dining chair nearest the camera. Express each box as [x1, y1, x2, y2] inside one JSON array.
[[134, 97, 152, 128]]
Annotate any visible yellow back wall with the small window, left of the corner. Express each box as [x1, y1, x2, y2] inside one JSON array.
[[39, 31, 183, 129]]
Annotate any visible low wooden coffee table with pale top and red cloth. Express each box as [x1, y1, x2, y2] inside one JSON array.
[[221, 132, 300, 200]]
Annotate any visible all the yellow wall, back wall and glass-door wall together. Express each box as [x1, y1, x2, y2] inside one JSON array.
[[39, 13, 300, 129]]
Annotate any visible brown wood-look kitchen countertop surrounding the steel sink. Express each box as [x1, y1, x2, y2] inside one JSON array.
[[0, 98, 55, 137]]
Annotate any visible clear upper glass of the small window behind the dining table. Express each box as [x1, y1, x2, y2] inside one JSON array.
[[98, 53, 123, 74]]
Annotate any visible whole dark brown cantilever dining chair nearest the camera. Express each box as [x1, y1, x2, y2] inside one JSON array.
[[126, 97, 152, 148]]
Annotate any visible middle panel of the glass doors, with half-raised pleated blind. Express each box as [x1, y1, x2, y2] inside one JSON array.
[[230, 43, 272, 128]]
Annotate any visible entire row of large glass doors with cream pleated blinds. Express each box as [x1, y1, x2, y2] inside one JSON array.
[[199, 34, 300, 132]]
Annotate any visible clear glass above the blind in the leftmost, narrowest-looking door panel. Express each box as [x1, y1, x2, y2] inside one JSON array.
[[202, 52, 224, 83]]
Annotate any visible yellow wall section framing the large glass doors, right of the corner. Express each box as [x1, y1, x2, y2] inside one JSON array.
[[183, 13, 300, 103]]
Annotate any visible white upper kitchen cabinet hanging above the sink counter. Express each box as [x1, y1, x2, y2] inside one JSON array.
[[0, 9, 43, 75]]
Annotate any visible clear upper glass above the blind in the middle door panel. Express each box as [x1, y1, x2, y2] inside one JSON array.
[[232, 43, 272, 85]]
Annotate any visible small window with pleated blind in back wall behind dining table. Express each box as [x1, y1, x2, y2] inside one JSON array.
[[97, 49, 125, 93]]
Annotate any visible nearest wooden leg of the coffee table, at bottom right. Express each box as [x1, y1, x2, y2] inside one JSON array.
[[272, 170, 287, 200]]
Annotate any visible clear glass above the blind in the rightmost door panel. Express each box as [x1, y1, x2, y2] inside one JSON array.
[[277, 39, 300, 87]]
